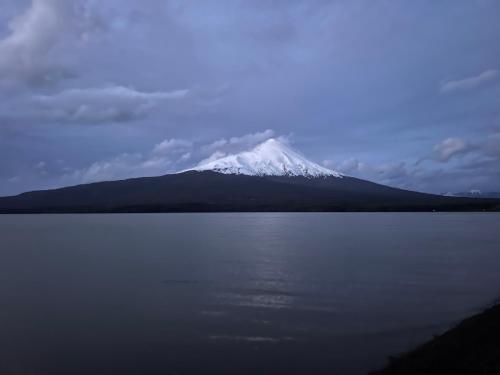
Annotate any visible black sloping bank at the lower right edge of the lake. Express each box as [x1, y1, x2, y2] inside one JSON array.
[[371, 305, 500, 375]]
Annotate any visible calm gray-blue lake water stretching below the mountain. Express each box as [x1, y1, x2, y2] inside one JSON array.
[[0, 213, 500, 375]]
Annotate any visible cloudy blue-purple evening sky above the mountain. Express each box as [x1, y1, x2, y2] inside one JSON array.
[[0, 0, 500, 195]]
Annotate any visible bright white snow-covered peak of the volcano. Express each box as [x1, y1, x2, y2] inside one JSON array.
[[190, 138, 342, 178]]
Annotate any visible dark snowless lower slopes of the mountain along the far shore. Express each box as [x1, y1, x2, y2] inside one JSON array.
[[0, 171, 500, 213]]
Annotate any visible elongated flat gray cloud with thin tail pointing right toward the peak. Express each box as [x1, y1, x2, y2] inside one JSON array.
[[34, 86, 189, 123]]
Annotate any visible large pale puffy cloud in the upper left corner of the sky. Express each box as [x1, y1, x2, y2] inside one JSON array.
[[0, 0, 100, 86]]
